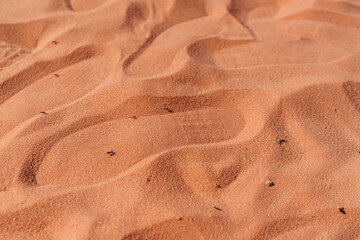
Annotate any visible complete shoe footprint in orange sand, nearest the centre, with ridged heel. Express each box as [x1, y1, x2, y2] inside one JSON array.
[[36, 108, 243, 185]]
